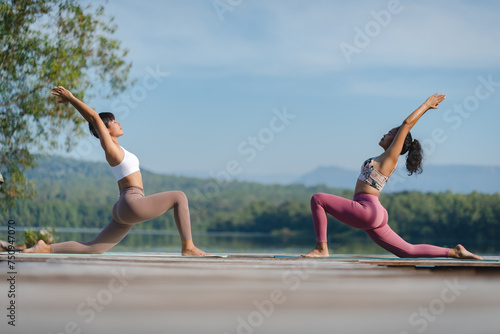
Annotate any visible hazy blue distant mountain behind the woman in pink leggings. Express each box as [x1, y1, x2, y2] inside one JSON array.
[[296, 165, 500, 194]]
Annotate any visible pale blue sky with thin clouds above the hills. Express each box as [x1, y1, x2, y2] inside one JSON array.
[[62, 0, 500, 177]]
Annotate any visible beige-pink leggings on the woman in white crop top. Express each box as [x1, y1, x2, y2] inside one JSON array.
[[51, 187, 191, 254]]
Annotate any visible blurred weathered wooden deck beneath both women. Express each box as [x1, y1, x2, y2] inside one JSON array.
[[0, 253, 500, 334]]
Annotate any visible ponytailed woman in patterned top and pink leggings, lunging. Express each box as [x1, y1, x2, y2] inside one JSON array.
[[302, 94, 482, 259]]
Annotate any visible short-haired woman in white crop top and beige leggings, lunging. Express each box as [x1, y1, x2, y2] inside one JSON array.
[[24, 86, 207, 255]]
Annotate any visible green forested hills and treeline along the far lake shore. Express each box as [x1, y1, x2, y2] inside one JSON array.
[[4, 156, 500, 248]]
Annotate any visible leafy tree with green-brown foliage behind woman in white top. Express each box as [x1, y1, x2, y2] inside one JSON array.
[[0, 0, 131, 210]]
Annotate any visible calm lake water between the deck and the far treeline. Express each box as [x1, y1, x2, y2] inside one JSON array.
[[0, 226, 500, 255]]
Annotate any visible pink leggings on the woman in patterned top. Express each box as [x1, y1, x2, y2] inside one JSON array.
[[311, 193, 449, 257]]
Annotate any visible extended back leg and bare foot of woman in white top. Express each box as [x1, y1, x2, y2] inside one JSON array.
[[24, 220, 134, 254]]
